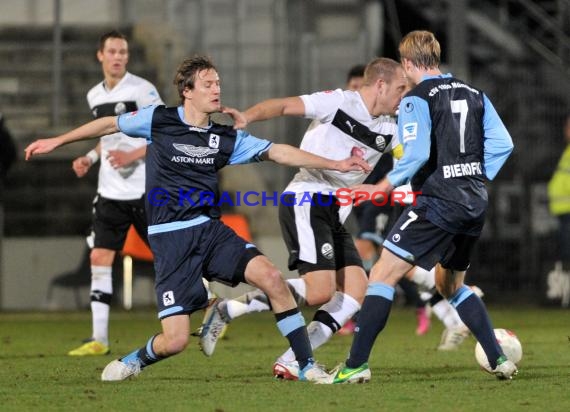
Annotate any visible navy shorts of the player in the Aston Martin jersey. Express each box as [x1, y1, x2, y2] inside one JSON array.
[[149, 220, 261, 319]]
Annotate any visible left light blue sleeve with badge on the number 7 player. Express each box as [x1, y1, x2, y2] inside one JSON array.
[[388, 96, 431, 186]]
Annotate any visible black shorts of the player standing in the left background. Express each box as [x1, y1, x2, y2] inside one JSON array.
[[91, 195, 148, 250]]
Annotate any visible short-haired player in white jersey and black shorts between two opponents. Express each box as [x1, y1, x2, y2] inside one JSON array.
[[200, 58, 407, 380]]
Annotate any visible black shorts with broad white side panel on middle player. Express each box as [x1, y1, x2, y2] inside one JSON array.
[[279, 194, 362, 275]]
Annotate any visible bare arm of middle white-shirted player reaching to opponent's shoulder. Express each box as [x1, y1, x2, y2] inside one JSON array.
[[222, 96, 305, 129]]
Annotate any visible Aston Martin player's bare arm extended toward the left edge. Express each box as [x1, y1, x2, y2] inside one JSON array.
[[24, 116, 119, 160]]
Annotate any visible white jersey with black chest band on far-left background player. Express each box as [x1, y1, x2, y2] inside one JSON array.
[[87, 72, 163, 200]]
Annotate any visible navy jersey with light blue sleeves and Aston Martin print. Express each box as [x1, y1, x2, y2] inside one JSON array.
[[117, 106, 271, 234]]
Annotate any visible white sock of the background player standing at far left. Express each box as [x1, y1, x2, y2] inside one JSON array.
[[91, 266, 113, 345]]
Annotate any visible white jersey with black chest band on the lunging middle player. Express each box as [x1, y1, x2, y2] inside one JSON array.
[[285, 89, 402, 196]]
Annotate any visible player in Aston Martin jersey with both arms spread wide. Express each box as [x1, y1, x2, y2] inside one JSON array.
[[25, 56, 370, 382]]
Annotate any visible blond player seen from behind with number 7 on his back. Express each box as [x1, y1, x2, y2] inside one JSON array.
[[330, 31, 517, 383]]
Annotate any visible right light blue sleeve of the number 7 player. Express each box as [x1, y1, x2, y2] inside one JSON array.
[[483, 95, 514, 180]]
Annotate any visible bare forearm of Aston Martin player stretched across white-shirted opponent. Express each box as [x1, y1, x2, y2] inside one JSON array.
[[264, 143, 372, 173]]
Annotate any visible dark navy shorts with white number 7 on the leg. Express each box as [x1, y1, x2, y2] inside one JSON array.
[[383, 206, 479, 271]]
